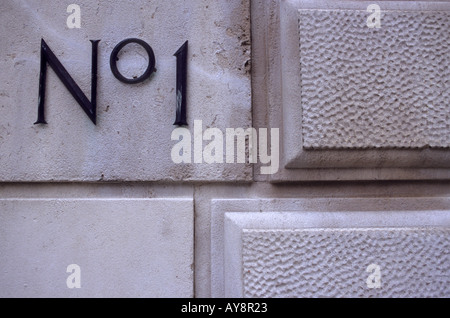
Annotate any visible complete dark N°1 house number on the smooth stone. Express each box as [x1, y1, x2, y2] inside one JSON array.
[[35, 38, 188, 126]]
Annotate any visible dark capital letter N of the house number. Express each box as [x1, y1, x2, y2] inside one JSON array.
[[35, 39, 100, 125]]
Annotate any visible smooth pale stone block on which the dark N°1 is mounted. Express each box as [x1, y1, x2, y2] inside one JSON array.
[[0, 0, 252, 182]]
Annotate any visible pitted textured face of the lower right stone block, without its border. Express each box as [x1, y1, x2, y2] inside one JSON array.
[[242, 228, 450, 297]]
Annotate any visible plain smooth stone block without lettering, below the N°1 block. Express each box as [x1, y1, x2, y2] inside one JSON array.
[[0, 199, 194, 298]]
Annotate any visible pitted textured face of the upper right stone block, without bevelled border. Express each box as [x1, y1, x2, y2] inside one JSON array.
[[299, 9, 450, 149]]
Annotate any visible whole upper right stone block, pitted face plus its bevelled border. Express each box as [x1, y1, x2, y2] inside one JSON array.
[[253, 0, 450, 182]]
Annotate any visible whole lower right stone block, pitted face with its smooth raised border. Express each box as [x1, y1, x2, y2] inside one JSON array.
[[211, 198, 450, 298]]
